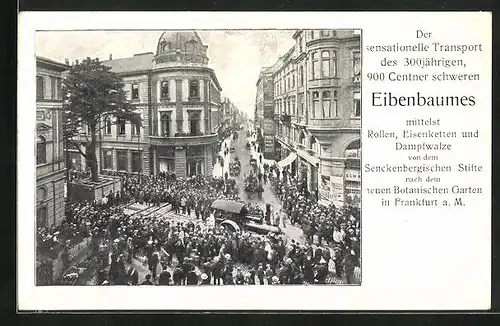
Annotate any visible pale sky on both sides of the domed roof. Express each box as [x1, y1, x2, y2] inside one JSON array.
[[36, 30, 294, 117]]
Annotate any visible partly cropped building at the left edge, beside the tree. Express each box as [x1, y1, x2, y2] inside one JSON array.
[[36, 57, 69, 228]]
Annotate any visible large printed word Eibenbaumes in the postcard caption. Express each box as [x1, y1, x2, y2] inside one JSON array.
[[372, 92, 476, 106]]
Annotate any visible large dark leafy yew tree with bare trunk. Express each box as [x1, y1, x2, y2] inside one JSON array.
[[62, 58, 142, 181]]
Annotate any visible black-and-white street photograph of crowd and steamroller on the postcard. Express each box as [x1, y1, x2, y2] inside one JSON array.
[[35, 28, 362, 286]]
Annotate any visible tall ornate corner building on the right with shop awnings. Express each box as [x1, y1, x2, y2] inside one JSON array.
[[273, 30, 361, 205]]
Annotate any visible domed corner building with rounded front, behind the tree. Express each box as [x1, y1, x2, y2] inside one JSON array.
[[100, 31, 222, 177]]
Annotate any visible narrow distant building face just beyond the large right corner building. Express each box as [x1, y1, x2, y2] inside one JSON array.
[[255, 67, 275, 159]]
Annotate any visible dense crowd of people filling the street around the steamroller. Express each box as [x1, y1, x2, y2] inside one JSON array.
[[37, 125, 360, 285]]
